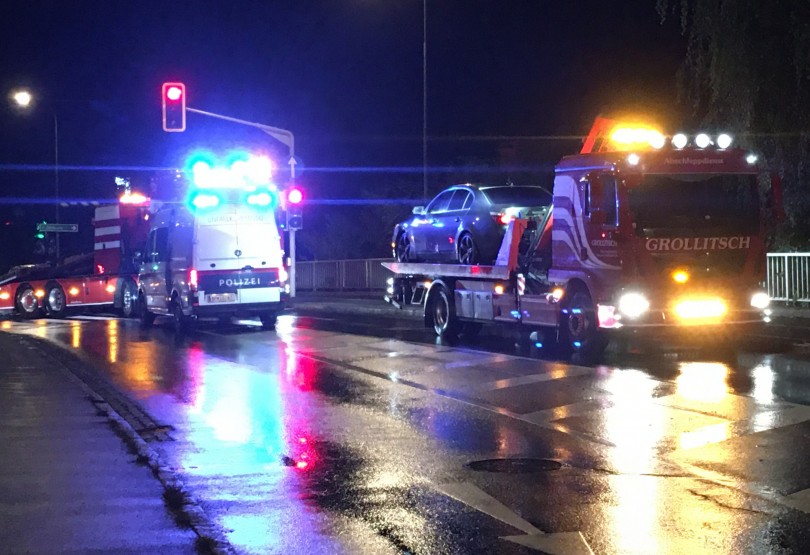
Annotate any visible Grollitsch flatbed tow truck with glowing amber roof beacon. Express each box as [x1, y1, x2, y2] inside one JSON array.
[[383, 117, 775, 359]]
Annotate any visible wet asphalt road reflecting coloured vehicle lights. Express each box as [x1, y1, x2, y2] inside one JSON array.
[[0, 313, 810, 554]]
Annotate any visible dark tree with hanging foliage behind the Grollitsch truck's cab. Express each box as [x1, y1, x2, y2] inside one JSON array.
[[657, 0, 810, 250]]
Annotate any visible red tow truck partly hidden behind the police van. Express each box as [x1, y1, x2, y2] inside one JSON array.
[[0, 192, 150, 319]]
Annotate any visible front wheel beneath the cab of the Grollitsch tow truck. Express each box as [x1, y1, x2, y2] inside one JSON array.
[[560, 289, 608, 361]]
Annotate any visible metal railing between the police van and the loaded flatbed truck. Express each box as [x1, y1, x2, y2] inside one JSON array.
[[295, 258, 391, 291]]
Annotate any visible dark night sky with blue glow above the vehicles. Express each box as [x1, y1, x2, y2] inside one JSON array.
[[0, 0, 686, 266]]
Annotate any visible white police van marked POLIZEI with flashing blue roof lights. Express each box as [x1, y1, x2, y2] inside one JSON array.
[[138, 177, 289, 330]]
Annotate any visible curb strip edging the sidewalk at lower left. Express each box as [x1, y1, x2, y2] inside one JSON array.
[[18, 335, 237, 555]]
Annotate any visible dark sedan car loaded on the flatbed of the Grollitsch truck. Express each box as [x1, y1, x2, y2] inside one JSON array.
[[392, 184, 551, 264]]
